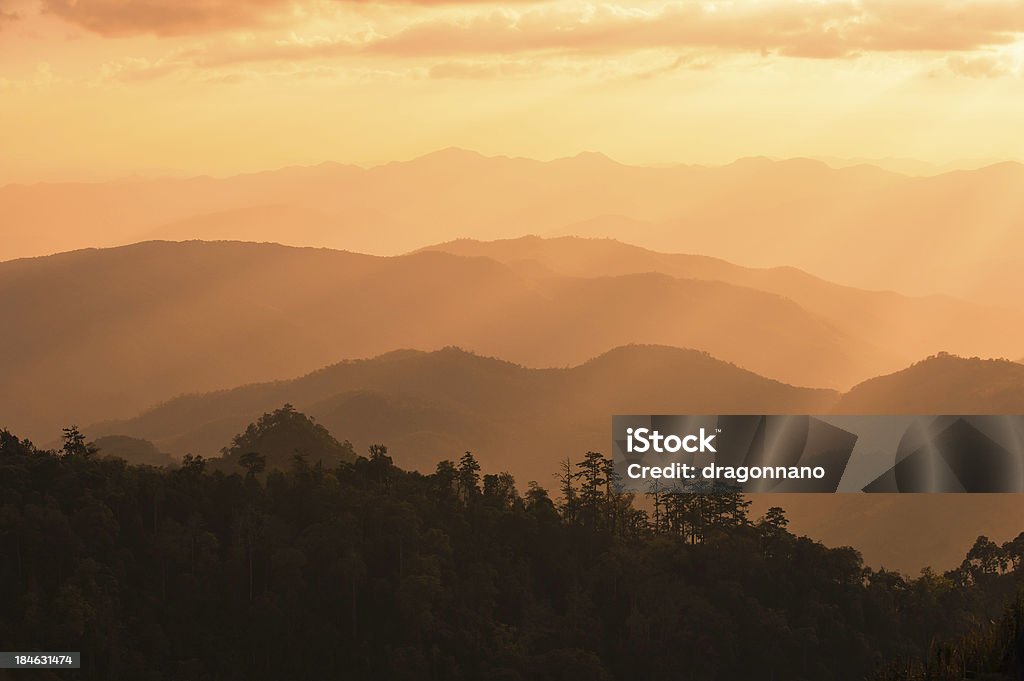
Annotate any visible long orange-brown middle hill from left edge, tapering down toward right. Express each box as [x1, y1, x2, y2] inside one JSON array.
[[0, 242, 880, 439]]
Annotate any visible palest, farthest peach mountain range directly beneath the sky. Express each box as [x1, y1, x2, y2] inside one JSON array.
[[6, 148, 1024, 308]]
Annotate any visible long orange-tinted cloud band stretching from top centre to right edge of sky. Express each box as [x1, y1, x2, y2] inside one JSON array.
[[368, 0, 1024, 58]]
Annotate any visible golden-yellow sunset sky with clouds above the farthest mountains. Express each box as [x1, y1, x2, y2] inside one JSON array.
[[6, 0, 1024, 182]]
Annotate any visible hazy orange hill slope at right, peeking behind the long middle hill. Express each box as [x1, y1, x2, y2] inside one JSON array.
[[417, 237, 1024, 368]]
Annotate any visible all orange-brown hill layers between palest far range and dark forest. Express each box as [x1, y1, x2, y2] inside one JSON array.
[[0, 229, 1024, 571]]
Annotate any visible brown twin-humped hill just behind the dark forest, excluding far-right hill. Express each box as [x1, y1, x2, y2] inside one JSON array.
[[89, 345, 838, 480]]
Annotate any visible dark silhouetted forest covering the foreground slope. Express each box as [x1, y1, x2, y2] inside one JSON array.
[[0, 406, 1024, 681]]
